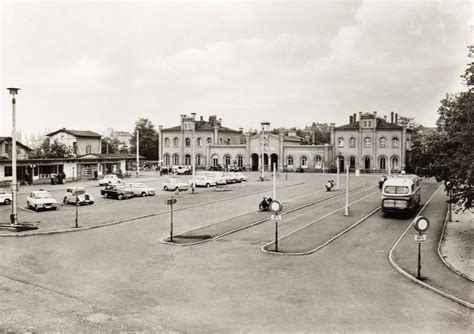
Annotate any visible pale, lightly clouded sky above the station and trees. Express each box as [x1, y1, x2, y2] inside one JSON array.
[[0, 0, 474, 142]]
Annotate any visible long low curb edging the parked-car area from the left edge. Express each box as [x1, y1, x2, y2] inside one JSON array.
[[0, 182, 305, 238]]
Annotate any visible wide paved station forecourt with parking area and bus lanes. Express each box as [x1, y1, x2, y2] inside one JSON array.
[[0, 173, 472, 333]]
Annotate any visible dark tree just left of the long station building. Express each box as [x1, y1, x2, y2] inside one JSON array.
[[130, 118, 158, 160]]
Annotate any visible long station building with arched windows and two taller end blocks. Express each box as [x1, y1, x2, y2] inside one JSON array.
[[158, 112, 411, 173]]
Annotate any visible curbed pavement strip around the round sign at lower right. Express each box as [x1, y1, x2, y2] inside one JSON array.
[[393, 190, 474, 304]]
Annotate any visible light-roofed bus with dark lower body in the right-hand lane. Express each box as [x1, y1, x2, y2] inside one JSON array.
[[382, 174, 421, 212]]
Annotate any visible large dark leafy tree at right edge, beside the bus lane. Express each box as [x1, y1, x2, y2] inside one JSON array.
[[417, 46, 474, 209]]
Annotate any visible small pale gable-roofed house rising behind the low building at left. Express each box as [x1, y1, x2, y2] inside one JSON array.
[[46, 128, 102, 156]]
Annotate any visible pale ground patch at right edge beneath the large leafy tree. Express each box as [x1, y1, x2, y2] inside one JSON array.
[[440, 204, 474, 281]]
